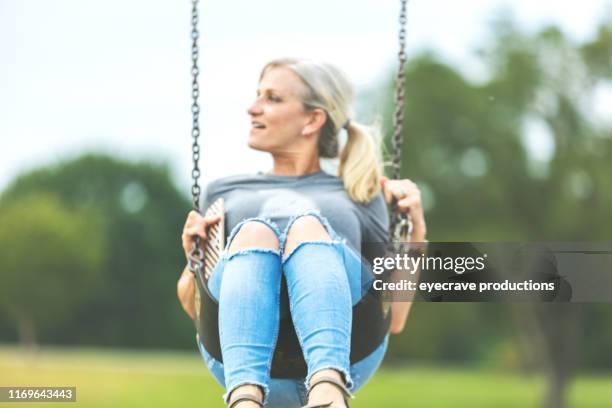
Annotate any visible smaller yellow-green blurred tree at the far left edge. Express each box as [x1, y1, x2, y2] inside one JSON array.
[[0, 194, 106, 348]]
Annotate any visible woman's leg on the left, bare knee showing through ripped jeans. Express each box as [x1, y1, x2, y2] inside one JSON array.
[[217, 219, 281, 408]]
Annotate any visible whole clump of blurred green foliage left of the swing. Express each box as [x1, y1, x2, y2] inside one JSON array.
[[0, 155, 193, 347]]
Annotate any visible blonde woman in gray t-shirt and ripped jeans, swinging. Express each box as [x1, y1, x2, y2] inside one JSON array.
[[178, 59, 426, 408]]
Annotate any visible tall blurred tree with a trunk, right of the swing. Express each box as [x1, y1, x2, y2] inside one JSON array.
[[368, 17, 612, 407]]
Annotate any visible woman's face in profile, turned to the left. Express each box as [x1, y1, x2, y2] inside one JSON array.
[[247, 67, 312, 153]]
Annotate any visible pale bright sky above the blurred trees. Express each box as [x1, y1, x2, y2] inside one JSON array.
[[0, 0, 612, 193]]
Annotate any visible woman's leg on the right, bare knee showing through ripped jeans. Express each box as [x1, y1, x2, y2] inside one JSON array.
[[283, 214, 353, 406]]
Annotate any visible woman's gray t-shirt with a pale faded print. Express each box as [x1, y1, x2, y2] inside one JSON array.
[[203, 171, 389, 261]]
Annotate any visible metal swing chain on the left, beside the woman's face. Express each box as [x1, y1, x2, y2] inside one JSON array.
[[187, 0, 204, 279]]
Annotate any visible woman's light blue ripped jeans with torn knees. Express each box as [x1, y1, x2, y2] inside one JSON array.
[[197, 211, 388, 408]]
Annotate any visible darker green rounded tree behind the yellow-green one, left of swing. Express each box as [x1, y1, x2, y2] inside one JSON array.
[[3, 155, 194, 347]]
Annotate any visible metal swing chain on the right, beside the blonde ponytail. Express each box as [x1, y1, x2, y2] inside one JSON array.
[[389, 0, 412, 241]]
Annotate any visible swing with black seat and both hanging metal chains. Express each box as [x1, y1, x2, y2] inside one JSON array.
[[188, 0, 412, 379]]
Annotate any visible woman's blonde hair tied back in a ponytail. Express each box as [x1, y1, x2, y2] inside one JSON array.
[[260, 58, 382, 203]]
